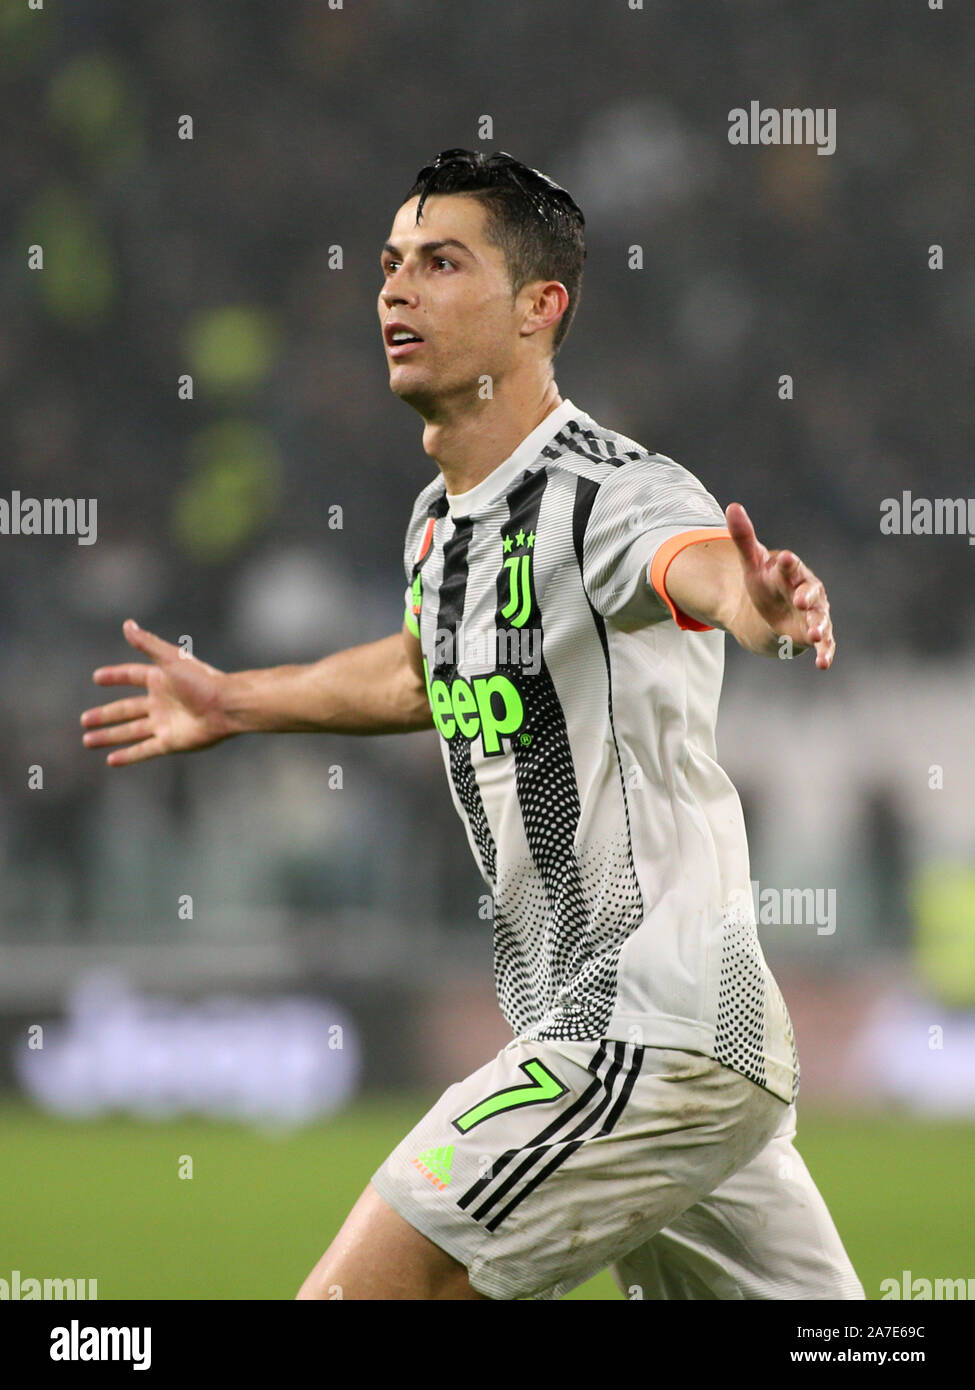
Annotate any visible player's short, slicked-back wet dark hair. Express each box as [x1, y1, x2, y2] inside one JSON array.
[[405, 150, 586, 356]]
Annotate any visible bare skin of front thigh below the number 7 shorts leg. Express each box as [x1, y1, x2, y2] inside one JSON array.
[[298, 1183, 485, 1300]]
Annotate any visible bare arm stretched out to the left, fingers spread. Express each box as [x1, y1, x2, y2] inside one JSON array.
[[81, 619, 433, 767]]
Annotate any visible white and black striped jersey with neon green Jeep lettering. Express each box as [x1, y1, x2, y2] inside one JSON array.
[[405, 400, 798, 1102]]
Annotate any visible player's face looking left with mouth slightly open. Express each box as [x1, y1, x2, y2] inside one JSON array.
[[378, 193, 520, 416]]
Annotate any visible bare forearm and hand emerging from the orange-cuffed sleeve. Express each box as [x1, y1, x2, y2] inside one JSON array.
[[665, 502, 836, 671]]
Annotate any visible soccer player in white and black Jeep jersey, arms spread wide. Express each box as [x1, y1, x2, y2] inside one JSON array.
[[82, 150, 864, 1300]]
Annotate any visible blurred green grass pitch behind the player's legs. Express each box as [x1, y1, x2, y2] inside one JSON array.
[[0, 1097, 975, 1300]]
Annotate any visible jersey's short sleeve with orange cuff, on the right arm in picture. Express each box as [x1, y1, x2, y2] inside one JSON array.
[[583, 453, 729, 631]]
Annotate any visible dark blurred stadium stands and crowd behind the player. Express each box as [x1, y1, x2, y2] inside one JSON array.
[[0, 0, 975, 1112]]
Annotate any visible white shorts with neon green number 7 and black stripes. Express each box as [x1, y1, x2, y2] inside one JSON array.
[[373, 1038, 864, 1300]]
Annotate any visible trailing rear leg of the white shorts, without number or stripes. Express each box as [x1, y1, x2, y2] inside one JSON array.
[[613, 1106, 864, 1300]]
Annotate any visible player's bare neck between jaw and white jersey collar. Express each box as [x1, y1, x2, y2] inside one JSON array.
[[423, 377, 562, 496]]
